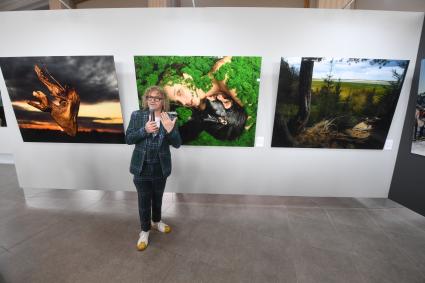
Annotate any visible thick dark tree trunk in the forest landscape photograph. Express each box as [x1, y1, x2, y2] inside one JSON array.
[[290, 59, 314, 135]]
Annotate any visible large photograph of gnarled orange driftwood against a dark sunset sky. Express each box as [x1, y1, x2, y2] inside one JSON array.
[[0, 56, 124, 143]]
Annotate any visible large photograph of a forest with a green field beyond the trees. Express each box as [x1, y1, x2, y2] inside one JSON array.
[[272, 57, 409, 149]]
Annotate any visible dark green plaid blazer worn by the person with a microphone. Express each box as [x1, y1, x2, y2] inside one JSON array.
[[125, 110, 182, 177]]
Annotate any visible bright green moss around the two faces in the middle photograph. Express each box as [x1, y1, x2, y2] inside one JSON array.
[[134, 56, 261, 146]]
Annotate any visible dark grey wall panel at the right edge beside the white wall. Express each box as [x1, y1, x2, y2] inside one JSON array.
[[389, 18, 425, 215]]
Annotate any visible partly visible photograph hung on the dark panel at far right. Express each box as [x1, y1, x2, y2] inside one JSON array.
[[412, 59, 425, 156]]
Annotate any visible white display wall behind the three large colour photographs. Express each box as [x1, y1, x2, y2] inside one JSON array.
[[0, 8, 424, 197]]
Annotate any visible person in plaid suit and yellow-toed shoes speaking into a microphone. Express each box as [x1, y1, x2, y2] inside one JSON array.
[[126, 86, 181, 251]]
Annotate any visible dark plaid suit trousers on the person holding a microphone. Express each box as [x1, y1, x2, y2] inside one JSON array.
[[133, 163, 167, 232]]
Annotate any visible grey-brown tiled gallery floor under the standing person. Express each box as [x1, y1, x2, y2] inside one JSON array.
[[0, 165, 425, 283]]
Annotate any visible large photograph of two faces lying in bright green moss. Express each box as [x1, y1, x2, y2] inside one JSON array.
[[134, 56, 261, 147]]
